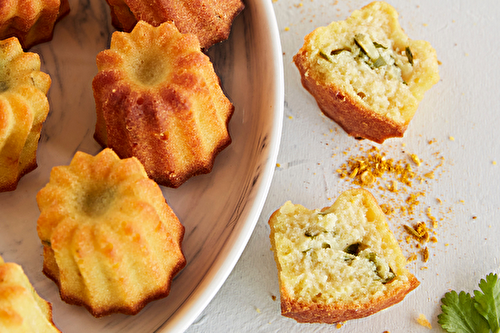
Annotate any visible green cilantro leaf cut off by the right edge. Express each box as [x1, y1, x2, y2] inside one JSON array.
[[474, 273, 500, 333]]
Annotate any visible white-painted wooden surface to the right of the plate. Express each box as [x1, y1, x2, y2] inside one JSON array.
[[187, 0, 500, 333]]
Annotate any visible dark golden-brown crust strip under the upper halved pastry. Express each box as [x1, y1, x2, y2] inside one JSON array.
[[293, 51, 408, 143]]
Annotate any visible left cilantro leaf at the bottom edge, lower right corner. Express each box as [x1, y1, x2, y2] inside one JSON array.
[[438, 290, 490, 333]]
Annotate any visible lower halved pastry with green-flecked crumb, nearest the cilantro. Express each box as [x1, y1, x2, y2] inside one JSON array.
[[269, 189, 419, 324]]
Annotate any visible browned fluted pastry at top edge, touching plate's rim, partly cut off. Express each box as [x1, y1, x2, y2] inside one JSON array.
[[106, 0, 245, 50]]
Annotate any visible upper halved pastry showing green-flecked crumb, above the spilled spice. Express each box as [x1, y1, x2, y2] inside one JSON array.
[[293, 2, 439, 143]]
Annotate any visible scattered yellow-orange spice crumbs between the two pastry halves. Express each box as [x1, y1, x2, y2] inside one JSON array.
[[334, 140, 454, 262]]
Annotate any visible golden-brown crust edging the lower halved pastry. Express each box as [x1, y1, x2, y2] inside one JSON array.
[[269, 189, 420, 324]]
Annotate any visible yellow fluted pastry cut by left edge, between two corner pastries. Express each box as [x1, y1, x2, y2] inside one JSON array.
[[0, 37, 51, 192]]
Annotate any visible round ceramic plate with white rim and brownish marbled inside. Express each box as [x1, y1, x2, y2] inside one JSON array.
[[0, 0, 284, 333]]
